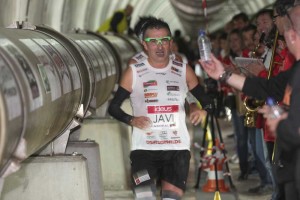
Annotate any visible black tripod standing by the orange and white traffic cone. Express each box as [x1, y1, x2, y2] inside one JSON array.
[[195, 106, 235, 191]]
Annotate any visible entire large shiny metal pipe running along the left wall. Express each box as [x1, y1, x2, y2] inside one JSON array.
[[0, 24, 138, 177]]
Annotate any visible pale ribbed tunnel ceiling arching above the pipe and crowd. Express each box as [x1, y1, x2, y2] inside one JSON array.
[[0, 0, 275, 45]]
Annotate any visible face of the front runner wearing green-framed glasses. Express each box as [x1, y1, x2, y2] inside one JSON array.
[[143, 28, 172, 62]]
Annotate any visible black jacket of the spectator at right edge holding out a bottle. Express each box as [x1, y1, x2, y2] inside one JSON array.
[[242, 61, 300, 183]]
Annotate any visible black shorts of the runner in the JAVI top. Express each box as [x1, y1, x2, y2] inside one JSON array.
[[130, 150, 191, 190]]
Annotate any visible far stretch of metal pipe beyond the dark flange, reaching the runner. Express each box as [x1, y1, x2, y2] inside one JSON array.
[[66, 31, 142, 108]]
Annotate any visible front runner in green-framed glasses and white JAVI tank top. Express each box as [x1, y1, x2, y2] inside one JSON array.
[[108, 19, 211, 199]]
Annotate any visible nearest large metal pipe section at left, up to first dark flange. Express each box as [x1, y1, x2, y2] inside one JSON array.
[[0, 23, 86, 177]]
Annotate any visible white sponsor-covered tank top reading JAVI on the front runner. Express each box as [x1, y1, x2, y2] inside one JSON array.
[[130, 59, 190, 150]]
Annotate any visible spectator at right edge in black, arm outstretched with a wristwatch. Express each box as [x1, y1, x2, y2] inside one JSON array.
[[200, 0, 300, 200]]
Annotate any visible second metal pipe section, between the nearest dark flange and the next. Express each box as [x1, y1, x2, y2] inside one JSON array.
[[67, 31, 120, 108]]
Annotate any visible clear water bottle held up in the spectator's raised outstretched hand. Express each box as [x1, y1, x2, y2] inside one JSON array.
[[198, 30, 211, 61]]
